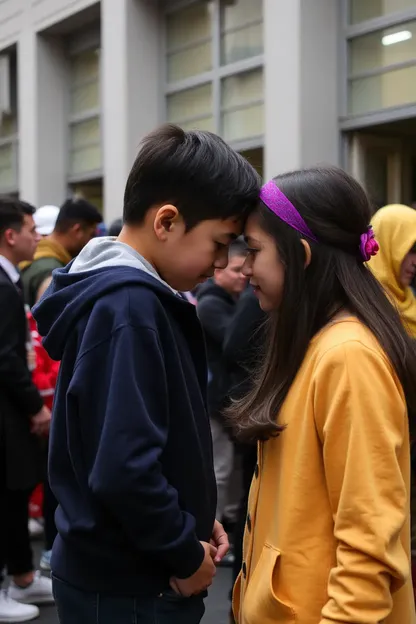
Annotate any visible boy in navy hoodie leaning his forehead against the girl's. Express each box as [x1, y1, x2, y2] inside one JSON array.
[[34, 125, 259, 624]]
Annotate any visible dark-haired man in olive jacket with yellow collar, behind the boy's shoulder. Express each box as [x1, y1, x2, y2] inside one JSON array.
[[21, 199, 102, 308]]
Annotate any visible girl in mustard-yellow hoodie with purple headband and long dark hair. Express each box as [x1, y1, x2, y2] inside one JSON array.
[[232, 168, 416, 624]]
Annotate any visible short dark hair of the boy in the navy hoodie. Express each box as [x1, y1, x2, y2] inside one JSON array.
[[124, 124, 260, 230]]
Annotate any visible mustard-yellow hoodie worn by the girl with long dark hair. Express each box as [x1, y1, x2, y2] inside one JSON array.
[[233, 317, 416, 624]]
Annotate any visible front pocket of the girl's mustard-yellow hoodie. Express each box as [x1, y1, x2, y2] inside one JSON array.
[[240, 544, 297, 624]]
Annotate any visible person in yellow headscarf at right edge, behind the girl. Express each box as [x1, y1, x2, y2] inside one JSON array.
[[368, 204, 416, 338]]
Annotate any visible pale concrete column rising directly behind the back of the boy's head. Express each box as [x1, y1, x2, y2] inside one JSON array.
[[101, 0, 162, 222]]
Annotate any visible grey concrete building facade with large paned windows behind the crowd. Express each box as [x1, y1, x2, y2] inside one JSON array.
[[0, 0, 416, 221]]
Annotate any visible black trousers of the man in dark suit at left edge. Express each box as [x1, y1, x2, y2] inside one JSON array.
[[0, 484, 33, 585]]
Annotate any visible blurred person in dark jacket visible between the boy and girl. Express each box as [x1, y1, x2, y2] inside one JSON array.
[[197, 240, 247, 540]]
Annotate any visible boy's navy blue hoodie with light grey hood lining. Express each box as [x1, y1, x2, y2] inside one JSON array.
[[34, 238, 216, 596]]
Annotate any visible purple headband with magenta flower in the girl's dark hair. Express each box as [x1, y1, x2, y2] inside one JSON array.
[[260, 180, 379, 262]]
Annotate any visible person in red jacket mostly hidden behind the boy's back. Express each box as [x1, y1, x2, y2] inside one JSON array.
[[26, 277, 59, 570]]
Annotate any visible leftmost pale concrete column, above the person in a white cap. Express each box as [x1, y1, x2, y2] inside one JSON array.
[[18, 23, 68, 206]]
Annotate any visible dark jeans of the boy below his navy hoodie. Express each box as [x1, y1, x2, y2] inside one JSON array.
[[52, 577, 205, 624]]
